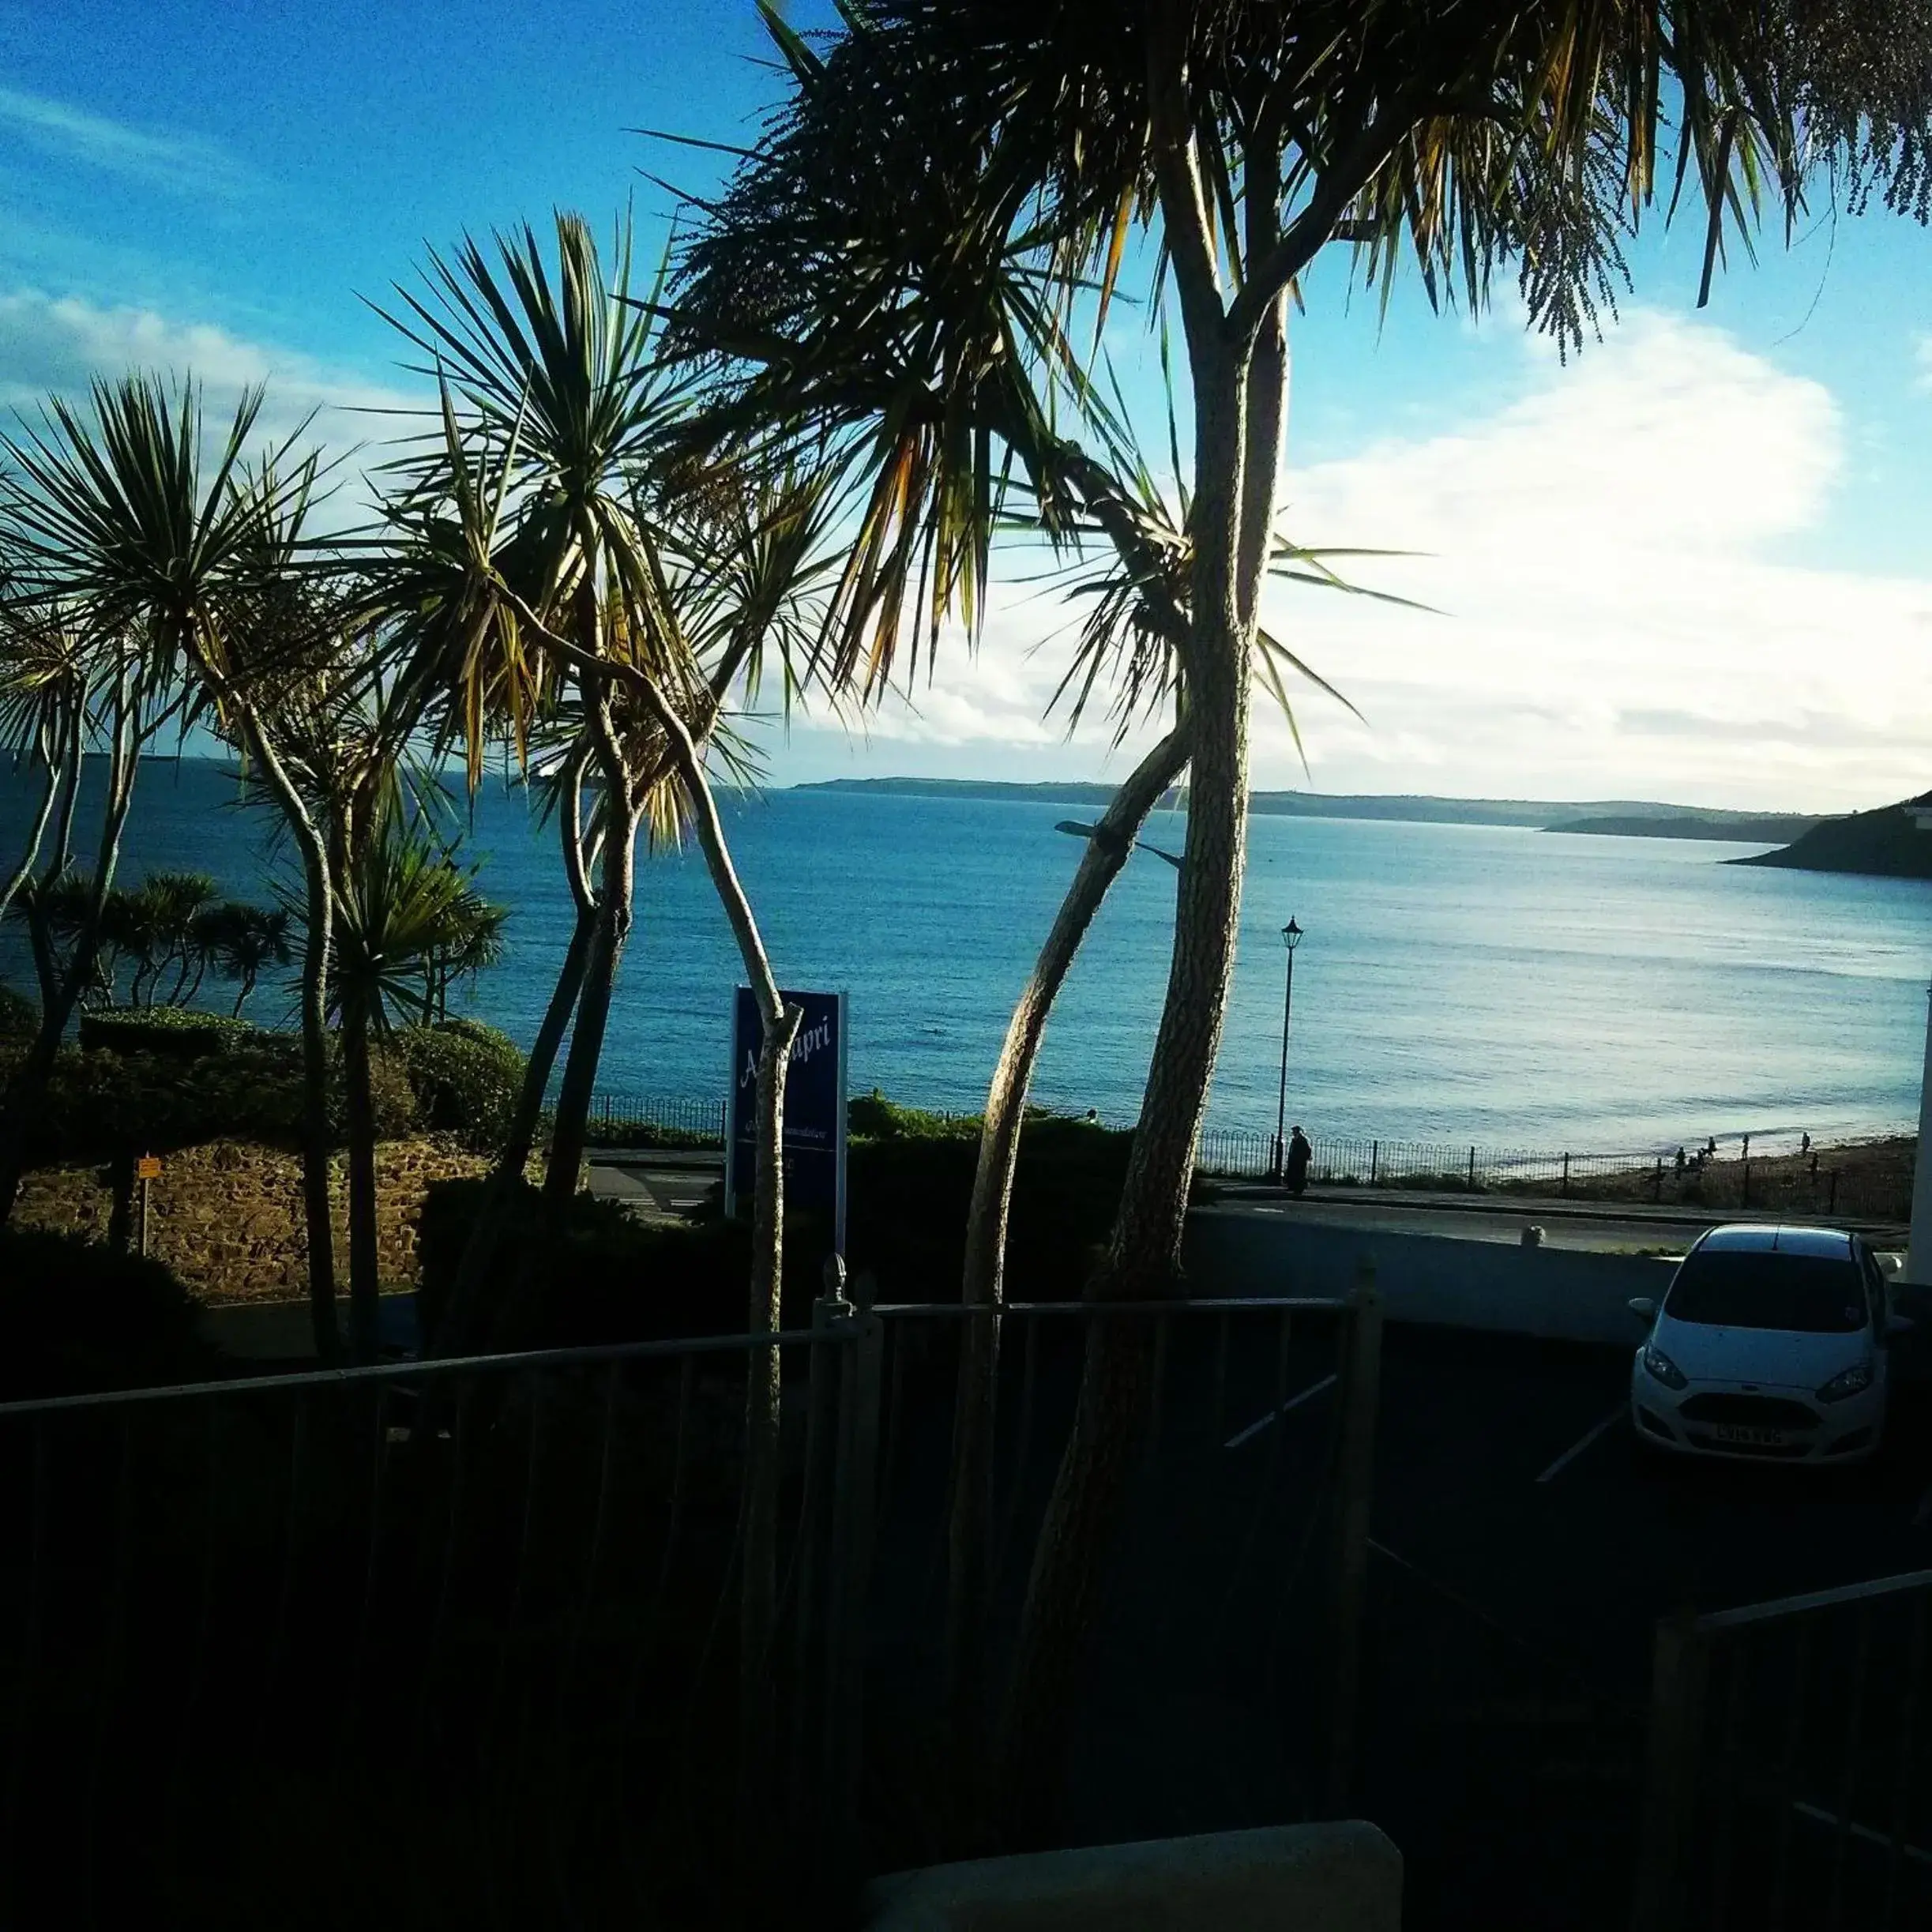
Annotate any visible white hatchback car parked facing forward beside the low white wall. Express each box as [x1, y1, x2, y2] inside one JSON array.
[[1630, 1227, 1911, 1463]]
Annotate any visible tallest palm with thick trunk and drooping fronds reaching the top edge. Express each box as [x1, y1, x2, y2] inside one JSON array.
[[678, 0, 1932, 1818]]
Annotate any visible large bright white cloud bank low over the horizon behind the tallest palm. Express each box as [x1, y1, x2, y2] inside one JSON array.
[[822, 311, 1932, 810]]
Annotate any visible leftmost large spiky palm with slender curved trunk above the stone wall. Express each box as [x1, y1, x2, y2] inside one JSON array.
[[0, 375, 338, 1362]]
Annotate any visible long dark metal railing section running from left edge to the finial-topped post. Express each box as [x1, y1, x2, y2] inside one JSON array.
[[0, 1310, 875, 1924]]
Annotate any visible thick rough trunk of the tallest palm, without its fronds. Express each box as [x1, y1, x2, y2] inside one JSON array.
[[1001, 333, 1279, 1836]]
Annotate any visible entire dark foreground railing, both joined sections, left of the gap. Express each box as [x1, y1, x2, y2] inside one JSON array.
[[0, 1295, 1379, 1926]]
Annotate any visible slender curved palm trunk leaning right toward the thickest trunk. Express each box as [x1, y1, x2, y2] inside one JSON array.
[[947, 727, 1188, 1814]]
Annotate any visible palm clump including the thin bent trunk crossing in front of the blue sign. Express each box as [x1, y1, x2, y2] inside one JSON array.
[[380, 215, 850, 1818]]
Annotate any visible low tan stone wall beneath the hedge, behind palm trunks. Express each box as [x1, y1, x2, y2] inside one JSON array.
[[16, 1136, 489, 1302]]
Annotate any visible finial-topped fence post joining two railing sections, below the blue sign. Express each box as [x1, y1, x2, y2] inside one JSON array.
[[823, 1275, 885, 1885]]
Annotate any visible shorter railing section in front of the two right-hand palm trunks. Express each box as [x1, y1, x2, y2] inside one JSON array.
[[871, 1271, 1381, 1829]]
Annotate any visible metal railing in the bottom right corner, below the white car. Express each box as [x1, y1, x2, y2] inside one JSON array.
[[1633, 1571, 1932, 1932]]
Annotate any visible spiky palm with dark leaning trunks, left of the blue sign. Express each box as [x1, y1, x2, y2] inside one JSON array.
[[374, 215, 825, 1283]]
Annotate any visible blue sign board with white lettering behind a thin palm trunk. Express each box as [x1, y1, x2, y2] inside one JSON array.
[[724, 985, 846, 1254]]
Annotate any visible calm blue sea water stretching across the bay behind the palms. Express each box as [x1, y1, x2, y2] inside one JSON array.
[[0, 761, 1932, 1152]]
